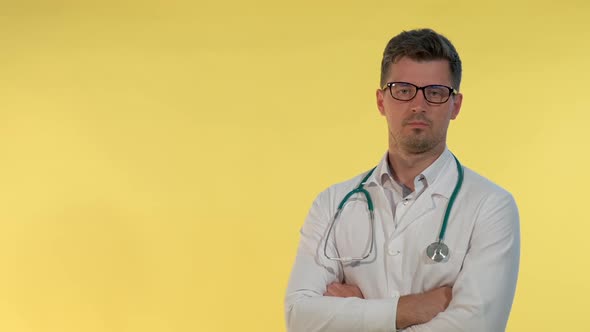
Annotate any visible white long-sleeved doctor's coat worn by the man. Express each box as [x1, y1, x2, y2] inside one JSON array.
[[285, 150, 520, 332]]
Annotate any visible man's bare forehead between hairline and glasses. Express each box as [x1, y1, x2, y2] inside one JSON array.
[[387, 57, 451, 86]]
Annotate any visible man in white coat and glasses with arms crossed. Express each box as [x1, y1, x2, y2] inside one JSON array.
[[285, 29, 520, 332]]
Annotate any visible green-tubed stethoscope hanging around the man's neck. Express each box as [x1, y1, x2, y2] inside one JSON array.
[[324, 155, 463, 263]]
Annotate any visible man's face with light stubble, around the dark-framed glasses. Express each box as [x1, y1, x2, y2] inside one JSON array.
[[377, 57, 463, 154]]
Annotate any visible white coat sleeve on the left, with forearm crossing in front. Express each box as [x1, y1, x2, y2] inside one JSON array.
[[285, 191, 398, 332]]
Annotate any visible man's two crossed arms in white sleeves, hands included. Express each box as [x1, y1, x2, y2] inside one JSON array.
[[286, 188, 519, 332]]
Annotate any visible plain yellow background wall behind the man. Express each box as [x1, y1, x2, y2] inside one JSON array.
[[0, 0, 590, 332]]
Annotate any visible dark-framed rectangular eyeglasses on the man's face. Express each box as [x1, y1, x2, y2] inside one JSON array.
[[382, 82, 458, 104]]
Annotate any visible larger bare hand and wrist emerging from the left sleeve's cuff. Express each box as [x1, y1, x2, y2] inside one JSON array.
[[396, 287, 453, 329]]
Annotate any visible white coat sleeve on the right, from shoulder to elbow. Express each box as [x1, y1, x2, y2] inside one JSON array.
[[404, 192, 520, 332]]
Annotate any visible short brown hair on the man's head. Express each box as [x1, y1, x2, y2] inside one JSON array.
[[380, 29, 462, 90]]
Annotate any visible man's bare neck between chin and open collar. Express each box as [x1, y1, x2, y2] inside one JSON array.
[[388, 144, 446, 191]]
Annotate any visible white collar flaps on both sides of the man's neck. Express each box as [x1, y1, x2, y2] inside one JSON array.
[[366, 148, 455, 198]]
